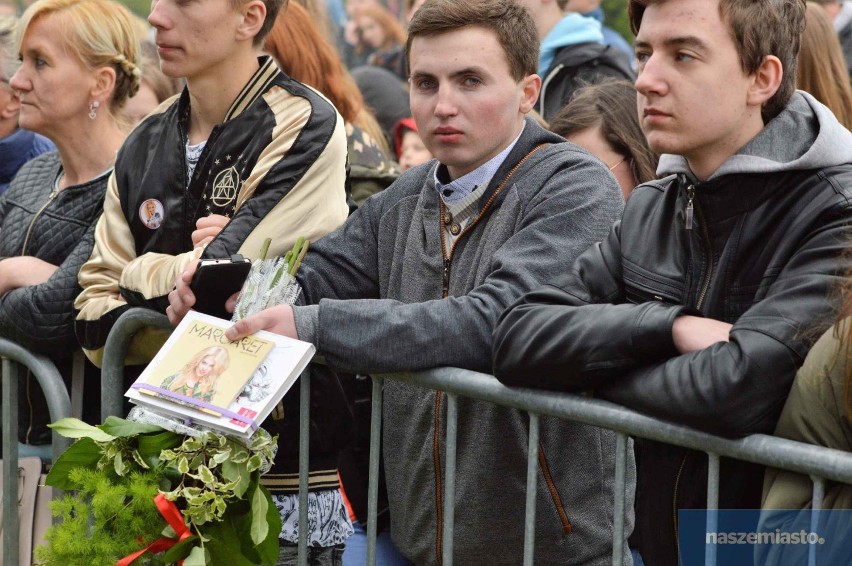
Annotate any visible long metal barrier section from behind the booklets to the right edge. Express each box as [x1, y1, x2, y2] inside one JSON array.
[[96, 309, 852, 566]]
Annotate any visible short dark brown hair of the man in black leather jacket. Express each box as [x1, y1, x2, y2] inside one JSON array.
[[627, 0, 805, 122]]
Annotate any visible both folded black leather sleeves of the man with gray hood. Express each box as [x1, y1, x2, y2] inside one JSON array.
[[494, 212, 848, 436]]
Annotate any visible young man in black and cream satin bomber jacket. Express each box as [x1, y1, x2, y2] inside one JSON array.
[[75, 0, 352, 554]]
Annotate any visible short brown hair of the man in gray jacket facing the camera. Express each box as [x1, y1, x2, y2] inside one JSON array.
[[405, 0, 539, 81]]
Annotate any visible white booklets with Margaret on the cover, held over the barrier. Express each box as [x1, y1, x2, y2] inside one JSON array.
[[125, 311, 315, 438]]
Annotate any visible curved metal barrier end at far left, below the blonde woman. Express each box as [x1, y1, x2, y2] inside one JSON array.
[[0, 338, 71, 564]]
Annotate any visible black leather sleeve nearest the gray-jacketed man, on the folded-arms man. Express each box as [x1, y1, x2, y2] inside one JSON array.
[[494, 223, 684, 391]]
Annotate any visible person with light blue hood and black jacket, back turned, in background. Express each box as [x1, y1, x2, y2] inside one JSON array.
[[520, 0, 634, 122]]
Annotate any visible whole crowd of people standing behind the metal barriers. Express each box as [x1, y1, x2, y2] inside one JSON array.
[[0, 0, 852, 566]]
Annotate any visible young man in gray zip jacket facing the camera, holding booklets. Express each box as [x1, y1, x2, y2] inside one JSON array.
[[170, 0, 633, 566]]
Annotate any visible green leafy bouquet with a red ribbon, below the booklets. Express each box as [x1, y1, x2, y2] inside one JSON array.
[[37, 417, 281, 566]]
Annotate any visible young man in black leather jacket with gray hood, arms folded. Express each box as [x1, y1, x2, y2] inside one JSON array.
[[493, 0, 852, 566]]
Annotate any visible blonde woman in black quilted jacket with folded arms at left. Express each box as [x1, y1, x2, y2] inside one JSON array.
[[0, 0, 139, 442]]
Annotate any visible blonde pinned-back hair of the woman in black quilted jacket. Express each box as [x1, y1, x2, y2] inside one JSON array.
[[17, 0, 142, 111]]
